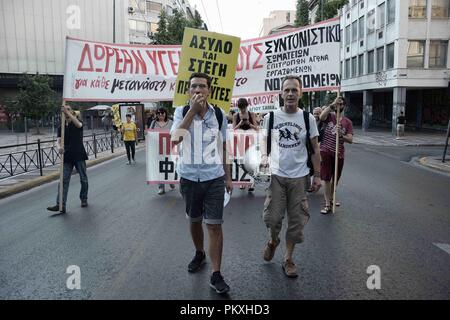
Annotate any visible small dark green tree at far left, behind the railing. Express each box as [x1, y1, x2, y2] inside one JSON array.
[[5, 74, 57, 134]]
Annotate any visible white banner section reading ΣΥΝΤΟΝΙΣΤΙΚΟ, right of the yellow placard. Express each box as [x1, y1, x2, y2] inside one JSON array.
[[233, 18, 341, 97]]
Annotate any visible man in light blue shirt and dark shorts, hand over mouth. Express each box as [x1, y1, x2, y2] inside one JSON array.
[[171, 73, 233, 293]]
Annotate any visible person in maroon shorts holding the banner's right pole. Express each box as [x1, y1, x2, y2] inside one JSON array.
[[320, 96, 353, 214]]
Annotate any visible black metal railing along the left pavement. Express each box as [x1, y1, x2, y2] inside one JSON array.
[[0, 131, 124, 179]]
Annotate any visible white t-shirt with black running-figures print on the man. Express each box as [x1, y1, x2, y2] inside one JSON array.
[[263, 109, 319, 178]]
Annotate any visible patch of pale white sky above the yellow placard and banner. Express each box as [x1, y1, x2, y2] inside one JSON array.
[[189, 0, 297, 40]]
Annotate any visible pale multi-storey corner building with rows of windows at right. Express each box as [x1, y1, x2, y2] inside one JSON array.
[[341, 0, 450, 133]]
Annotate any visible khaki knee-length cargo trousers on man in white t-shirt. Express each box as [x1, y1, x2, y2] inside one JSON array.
[[263, 175, 309, 243]]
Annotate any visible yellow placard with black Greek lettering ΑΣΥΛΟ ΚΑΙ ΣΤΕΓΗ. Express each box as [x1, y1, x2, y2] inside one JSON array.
[[173, 28, 241, 112]]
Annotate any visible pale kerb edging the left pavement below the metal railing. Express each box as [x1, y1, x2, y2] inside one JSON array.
[[0, 151, 126, 199]]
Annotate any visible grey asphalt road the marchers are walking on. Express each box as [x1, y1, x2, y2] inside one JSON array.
[[0, 145, 450, 299]]
